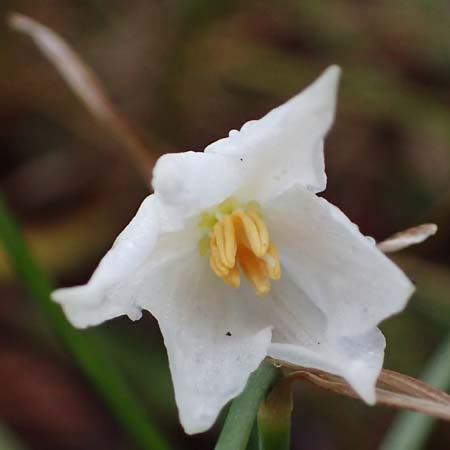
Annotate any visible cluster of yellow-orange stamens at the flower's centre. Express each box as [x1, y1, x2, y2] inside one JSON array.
[[199, 198, 281, 296]]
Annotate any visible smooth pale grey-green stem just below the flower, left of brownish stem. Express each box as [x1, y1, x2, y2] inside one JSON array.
[[215, 363, 280, 450]]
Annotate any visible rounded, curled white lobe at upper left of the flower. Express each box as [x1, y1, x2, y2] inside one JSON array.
[[152, 152, 246, 223]]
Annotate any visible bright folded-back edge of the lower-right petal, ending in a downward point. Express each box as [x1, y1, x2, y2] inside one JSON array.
[[268, 328, 385, 404]]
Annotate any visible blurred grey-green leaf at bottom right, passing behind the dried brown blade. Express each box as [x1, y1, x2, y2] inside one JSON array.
[[380, 335, 450, 450]]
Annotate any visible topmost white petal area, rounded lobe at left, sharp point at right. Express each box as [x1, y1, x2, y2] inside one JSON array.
[[149, 67, 340, 220]]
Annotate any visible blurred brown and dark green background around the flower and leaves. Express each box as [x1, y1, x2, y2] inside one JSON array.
[[0, 0, 450, 450]]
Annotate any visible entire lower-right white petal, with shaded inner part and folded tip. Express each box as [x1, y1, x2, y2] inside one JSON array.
[[269, 273, 384, 403]]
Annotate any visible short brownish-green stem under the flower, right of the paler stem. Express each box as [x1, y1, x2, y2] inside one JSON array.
[[258, 378, 293, 450]]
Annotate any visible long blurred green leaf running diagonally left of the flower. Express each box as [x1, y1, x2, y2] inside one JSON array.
[[0, 197, 169, 450]]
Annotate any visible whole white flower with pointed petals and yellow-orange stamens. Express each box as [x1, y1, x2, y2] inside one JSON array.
[[53, 67, 413, 433]]
